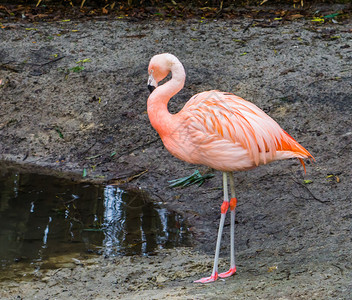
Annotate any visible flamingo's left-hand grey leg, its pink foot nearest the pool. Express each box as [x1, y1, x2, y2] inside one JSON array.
[[195, 172, 230, 283]]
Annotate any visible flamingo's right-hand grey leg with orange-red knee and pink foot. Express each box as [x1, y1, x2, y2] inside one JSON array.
[[219, 172, 237, 278]]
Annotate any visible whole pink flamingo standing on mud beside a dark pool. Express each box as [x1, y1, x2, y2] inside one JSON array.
[[147, 53, 314, 283]]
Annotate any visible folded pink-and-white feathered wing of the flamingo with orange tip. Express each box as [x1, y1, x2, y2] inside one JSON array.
[[179, 91, 312, 166]]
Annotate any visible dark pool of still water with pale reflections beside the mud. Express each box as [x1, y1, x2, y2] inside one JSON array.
[[0, 164, 190, 277]]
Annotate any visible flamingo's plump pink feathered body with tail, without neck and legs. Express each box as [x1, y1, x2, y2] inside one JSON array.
[[157, 90, 310, 171]]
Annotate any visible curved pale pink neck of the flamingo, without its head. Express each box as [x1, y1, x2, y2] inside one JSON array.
[[147, 60, 186, 137]]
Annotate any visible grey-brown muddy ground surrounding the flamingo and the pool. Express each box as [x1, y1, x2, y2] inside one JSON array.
[[0, 7, 352, 299]]
